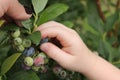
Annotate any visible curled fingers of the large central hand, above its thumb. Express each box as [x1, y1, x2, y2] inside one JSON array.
[[38, 21, 79, 47]]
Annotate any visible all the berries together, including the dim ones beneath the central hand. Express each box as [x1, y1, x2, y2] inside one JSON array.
[[11, 29, 74, 80]]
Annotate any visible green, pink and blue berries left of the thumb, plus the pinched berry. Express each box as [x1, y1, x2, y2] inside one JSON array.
[[11, 29, 49, 72]]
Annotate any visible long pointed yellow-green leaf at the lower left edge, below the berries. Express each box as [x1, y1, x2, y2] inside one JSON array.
[[1, 53, 21, 75]]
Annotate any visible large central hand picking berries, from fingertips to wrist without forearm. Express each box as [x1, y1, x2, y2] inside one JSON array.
[[38, 21, 91, 71]]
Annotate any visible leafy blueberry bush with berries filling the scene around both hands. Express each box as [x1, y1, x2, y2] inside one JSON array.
[[0, 0, 120, 80]]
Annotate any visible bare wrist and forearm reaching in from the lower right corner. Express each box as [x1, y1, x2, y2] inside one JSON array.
[[79, 54, 120, 80]]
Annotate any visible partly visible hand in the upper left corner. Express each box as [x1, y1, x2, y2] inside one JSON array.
[[0, 0, 31, 20]]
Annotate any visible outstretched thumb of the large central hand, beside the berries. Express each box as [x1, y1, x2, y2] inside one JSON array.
[[40, 43, 72, 67]]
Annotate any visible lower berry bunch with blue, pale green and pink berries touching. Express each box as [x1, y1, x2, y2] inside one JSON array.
[[22, 47, 48, 72]]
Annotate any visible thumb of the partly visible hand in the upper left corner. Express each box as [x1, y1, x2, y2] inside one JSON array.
[[6, 0, 31, 20]]
